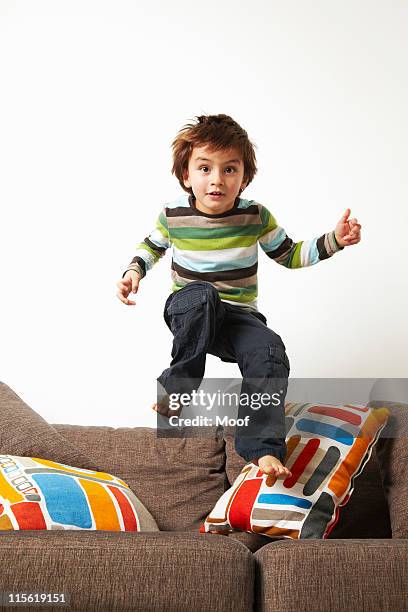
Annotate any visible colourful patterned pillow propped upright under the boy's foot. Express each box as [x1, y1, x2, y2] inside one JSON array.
[[200, 403, 389, 539]]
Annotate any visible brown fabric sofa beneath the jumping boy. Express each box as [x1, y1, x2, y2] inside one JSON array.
[[0, 384, 408, 612]]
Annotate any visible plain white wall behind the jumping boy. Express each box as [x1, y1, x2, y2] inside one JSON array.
[[0, 0, 408, 426]]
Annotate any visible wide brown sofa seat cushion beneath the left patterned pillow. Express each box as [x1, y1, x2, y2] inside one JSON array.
[[0, 531, 255, 612]]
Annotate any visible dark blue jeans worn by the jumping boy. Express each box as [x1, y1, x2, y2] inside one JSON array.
[[157, 281, 290, 462]]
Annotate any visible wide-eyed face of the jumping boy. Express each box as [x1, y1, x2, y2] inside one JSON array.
[[184, 145, 247, 215]]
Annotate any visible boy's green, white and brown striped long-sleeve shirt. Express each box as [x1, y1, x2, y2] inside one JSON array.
[[123, 193, 343, 310]]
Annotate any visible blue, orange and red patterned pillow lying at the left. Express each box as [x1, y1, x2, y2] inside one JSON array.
[[0, 455, 159, 531]]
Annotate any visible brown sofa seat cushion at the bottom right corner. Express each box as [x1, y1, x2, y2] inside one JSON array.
[[254, 539, 408, 612]]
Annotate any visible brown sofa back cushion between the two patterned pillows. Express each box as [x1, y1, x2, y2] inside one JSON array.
[[54, 424, 226, 531]]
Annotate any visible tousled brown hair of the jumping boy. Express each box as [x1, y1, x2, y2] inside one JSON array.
[[171, 114, 257, 195]]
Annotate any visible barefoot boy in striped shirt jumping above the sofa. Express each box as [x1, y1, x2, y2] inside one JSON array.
[[117, 114, 361, 478]]
